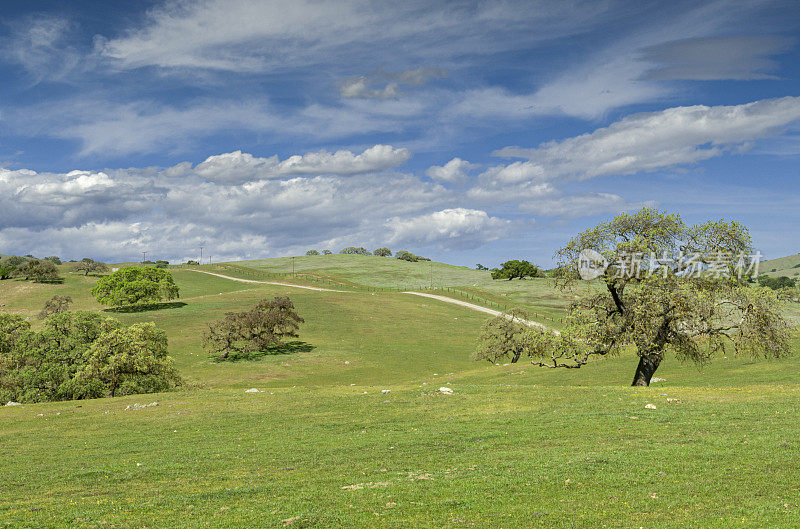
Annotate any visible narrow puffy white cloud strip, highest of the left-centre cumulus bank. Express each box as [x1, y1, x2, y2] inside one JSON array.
[[194, 145, 411, 183]]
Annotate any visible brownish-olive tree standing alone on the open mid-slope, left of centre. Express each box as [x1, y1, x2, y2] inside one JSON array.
[[203, 297, 305, 360]]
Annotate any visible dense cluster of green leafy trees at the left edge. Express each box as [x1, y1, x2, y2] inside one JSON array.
[[0, 312, 181, 402]]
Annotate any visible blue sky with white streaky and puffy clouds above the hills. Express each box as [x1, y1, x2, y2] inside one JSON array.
[[0, 0, 800, 267]]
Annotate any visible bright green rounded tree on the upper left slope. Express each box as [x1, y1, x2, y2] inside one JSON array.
[[90, 266, 179, 307]]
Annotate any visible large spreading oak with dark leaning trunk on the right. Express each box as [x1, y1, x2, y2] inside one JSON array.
[[478, 208, 791, 386]]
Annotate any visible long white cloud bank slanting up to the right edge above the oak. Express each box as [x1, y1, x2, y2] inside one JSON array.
[[483, 97, 800, 183]]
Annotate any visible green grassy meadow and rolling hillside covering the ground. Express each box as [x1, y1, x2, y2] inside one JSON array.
[[0, 255, 800, 529]]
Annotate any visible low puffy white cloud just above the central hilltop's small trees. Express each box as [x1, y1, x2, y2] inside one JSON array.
[[385, 208, 511, 249]]
